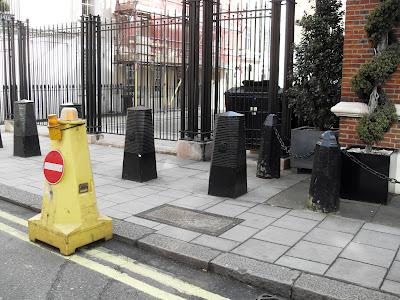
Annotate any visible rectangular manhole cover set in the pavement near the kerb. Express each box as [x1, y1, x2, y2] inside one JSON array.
[[137, 204, 243, 236]]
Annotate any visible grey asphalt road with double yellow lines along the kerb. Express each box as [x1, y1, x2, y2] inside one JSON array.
[[0, 200, 278, 300]]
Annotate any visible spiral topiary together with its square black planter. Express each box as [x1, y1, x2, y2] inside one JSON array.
[[341, 0, 400, 204]]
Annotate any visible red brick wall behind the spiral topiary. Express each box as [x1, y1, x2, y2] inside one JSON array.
[[339, 0, 400, 148]]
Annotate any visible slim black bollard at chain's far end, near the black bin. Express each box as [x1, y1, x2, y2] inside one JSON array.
[[256, 114, 281, 179]]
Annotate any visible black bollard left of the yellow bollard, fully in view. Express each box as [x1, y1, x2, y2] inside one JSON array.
[[14, 100, 41, 157]]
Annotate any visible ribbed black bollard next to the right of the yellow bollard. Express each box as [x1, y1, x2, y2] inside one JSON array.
[[122, 107, 157, 182]]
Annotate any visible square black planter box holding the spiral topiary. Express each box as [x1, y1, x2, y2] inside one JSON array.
[[340, 147, 393, 204]]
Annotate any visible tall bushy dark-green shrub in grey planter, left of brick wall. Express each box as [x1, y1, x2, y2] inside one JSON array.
[[286, 0, 343, 169]]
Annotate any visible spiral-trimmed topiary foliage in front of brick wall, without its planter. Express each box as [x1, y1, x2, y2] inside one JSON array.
[[352, 0, 400, 151]]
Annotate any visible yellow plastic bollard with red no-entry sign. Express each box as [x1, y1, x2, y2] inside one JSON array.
[[28, 108, 112, 255]]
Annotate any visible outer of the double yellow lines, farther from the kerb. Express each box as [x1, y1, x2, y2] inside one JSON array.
[[0, 222, 184, 300]]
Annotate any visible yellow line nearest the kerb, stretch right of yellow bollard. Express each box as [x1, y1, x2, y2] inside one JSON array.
[[84, 248, 228, 300]]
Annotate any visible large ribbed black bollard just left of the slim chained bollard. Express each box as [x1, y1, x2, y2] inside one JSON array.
[[208, 112, 247, 198]]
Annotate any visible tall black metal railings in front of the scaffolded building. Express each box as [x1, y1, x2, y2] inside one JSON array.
[[0, 0, 271, 140]]
